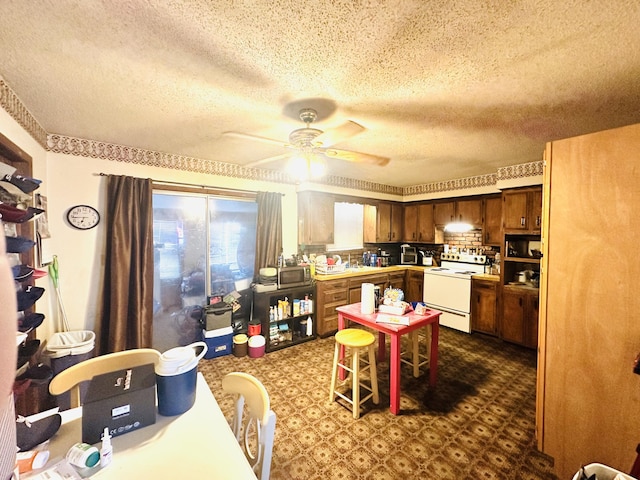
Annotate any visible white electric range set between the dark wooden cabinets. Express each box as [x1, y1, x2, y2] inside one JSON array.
[[423, 253, 487, 333]]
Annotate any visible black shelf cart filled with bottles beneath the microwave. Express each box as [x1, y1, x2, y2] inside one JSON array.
[[252, 284, 316, 352]]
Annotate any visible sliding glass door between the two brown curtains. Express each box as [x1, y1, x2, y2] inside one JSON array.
[[153, 191, 257, 352]]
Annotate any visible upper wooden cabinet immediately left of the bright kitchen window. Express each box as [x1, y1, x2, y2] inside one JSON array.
[[298, 192, 335, 245]]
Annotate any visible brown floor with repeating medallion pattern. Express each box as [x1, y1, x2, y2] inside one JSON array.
[[200, 328, 556, 480]]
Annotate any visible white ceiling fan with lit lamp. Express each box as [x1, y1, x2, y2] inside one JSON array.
[[224, 108, 390, 167]]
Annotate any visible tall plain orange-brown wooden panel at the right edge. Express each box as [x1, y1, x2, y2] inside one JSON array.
[[537, 124, 640, 478]]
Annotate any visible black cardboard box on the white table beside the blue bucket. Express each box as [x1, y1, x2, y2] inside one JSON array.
[[82, 363, 156, 444]]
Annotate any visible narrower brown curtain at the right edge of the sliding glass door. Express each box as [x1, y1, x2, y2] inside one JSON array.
[[254, 192, 282, 280]]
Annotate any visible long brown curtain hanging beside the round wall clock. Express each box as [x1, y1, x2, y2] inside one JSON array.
[[98, 175, 153, 354]]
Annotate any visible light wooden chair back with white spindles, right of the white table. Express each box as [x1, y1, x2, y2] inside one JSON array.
[[222, 372, 276, 480]]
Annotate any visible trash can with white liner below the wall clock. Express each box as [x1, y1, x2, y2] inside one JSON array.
[[43, 330, 96, 410]]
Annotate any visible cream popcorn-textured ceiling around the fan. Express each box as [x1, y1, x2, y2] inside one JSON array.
[[0, 0, 640, 186]]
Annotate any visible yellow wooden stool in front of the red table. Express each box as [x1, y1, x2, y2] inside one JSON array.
[[329, 328, 380, 419]]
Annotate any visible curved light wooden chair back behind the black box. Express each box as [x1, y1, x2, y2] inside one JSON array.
[[49, 348, 160, 408]]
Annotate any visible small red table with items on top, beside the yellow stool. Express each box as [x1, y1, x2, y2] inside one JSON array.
[[336, 303, 441, 415]]
